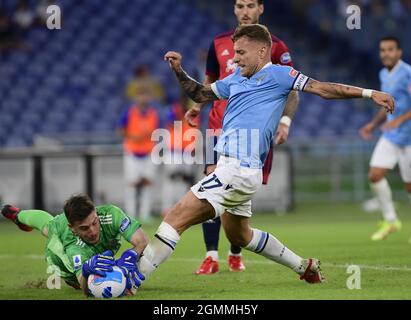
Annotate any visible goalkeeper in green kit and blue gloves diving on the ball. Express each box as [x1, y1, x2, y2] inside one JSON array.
[[1, 194, 147, 295]]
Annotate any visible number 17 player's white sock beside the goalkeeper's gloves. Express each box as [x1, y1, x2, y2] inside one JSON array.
[[138, 221, 180, 278]]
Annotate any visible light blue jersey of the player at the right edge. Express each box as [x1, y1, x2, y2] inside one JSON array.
[[380, 60, 411, 146]]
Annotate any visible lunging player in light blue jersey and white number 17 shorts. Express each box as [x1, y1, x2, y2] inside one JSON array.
[[139, 24, 394, 283]]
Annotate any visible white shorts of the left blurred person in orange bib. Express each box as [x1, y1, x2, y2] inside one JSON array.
[[124, 152, 155, 183]]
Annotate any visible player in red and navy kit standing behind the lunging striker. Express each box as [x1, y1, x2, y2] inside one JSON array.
[[190, 0, 298, 275]]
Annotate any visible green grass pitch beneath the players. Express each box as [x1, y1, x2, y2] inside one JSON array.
[[0, 203, 411, 300]]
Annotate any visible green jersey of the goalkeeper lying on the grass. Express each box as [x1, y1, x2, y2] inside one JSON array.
[[46, 205, 141, 286]]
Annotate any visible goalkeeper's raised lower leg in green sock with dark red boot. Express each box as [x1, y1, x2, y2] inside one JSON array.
[[1, 204, 53, 237]]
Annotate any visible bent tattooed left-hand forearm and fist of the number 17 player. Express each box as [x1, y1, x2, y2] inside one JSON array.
[[164, 51, 218, 103]]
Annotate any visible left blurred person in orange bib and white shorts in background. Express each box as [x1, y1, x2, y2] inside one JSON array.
[[118, 85, 160, 223]]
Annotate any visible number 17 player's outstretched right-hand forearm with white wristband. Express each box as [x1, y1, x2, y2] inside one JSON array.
[[303, 78, 395, 113]]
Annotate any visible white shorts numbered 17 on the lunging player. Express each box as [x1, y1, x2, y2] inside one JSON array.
[[191, 156, 262, 218]]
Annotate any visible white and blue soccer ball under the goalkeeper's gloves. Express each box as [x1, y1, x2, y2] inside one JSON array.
[[87, 266, 127, 298]]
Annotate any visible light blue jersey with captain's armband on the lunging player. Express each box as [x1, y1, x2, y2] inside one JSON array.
[[211, 63, 308, 168]]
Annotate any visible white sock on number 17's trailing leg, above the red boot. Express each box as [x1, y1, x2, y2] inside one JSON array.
[[245, 229, 304, 274]]
